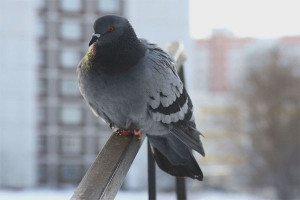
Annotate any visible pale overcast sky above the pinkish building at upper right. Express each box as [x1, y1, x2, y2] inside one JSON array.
[[190, 0, 300, 38]]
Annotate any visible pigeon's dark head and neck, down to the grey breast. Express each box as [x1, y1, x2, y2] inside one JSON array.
[[87, 15, 146, 75]]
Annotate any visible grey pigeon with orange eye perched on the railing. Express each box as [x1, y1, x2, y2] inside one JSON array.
[[77, 15, 205, 181]]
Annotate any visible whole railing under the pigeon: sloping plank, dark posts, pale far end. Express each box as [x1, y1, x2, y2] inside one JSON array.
[[71, 42, 186, 200]]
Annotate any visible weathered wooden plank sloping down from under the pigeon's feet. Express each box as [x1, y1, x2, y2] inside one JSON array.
[[71, 133, 145, 200]]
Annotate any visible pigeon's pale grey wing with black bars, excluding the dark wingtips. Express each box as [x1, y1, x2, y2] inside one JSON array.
[[142, 40, 194, 124]]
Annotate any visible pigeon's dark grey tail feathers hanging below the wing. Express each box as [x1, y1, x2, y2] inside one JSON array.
[[147, 126, 204, 181]]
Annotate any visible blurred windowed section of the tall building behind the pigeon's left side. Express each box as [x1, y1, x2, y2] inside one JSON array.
[[37, 0, 124, 186]]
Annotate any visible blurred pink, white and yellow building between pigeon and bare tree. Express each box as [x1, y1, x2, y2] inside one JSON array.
[[189, 30, 300, 189]]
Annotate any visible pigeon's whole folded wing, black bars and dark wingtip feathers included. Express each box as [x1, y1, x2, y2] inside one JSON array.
[[144, 39, 205, 156]]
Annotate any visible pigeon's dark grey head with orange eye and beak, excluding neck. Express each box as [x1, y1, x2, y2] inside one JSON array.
[[89, 15, 136, 46]]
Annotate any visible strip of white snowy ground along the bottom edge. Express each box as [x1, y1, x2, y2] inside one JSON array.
[[0, 189, 267, 200]]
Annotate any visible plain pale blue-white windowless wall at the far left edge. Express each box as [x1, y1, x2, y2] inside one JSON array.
[[0, 0, 37, 188]]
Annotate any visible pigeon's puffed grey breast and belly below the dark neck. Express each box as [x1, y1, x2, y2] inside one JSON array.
[[79, 59, 147, 129]]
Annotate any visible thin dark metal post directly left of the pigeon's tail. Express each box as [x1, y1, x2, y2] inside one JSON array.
[[147, 140, 156, 200]]
